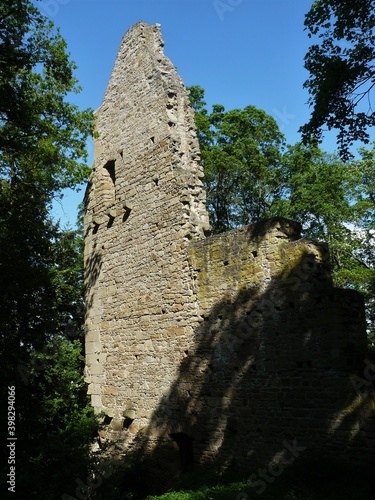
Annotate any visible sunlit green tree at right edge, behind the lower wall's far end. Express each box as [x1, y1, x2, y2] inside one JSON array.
[[279, 144, 375, 300]]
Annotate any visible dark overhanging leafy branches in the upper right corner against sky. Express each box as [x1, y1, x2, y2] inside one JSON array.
[[301, 0, 375, 159]]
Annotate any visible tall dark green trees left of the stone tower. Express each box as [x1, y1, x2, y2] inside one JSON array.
[[0, 0, 96, 499]]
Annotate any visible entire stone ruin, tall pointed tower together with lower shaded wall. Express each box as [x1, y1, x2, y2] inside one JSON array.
[[85, 22, 375, 468]]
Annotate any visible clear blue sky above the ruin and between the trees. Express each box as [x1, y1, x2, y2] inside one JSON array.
[[37, 0, 335, 226]]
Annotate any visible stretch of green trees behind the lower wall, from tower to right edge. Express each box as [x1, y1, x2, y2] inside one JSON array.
[[190, 86, 375, 340]]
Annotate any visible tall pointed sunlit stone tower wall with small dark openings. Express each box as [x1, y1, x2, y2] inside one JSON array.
[[85, 22, 209, 434]]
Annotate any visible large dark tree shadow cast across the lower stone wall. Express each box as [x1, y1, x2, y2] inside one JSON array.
[[126, 235, 375, 492]]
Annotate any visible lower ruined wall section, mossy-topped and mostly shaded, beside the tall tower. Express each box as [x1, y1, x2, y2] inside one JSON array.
[[92, 218, 375, 476]]
